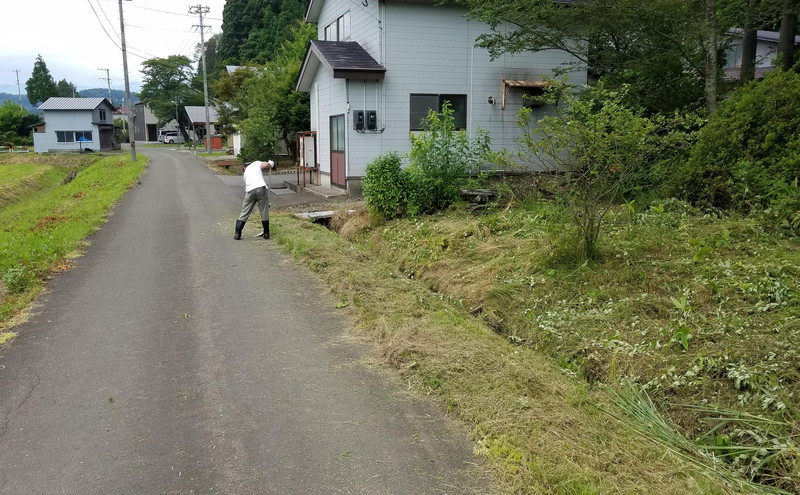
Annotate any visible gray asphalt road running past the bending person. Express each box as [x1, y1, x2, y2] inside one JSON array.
[[0, 150, 486, 495]]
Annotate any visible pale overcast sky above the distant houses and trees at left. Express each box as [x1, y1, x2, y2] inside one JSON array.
[[0, 0, 225, 95]]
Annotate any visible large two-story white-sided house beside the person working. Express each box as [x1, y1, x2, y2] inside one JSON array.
[[296, 0, 586, 193]]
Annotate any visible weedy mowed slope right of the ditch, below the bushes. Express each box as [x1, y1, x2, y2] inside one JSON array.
[[359, 194, 800, 493]]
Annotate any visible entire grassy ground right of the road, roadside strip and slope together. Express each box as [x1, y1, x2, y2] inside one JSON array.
[[268, 182, 800, 494]]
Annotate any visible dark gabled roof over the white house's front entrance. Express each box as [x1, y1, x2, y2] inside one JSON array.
[[296, 40, 386, 92]]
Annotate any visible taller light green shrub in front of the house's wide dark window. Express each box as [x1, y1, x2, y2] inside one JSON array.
[[408, 102, 489, 215]]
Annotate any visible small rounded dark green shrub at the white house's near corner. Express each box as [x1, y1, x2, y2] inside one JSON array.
[[363, 153, 408, 220]]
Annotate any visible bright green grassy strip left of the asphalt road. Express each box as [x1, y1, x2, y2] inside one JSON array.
[[0, 154, 146, 344]]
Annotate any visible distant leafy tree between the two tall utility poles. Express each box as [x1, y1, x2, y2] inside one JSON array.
[[139, 55, 196, 140]]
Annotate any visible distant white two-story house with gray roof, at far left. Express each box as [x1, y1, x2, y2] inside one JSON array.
[[33, 97, 118, 153]]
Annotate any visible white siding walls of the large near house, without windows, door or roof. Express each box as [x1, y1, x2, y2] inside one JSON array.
[[311, 0, 586, 183]]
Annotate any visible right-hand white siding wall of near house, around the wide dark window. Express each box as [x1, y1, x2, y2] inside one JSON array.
[[381, 3, 586, 167]]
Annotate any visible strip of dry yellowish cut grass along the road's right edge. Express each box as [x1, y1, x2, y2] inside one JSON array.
[[274, 214, 776, 494]]
